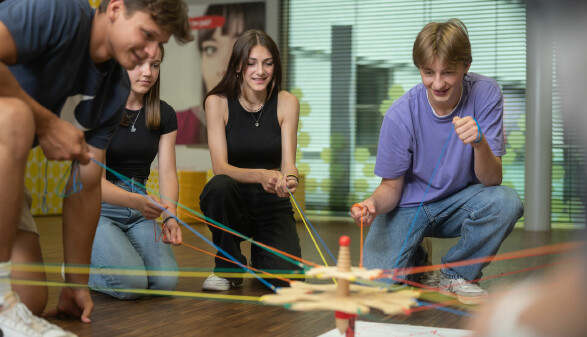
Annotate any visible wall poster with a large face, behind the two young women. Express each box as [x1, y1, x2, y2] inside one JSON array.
[[172, 1, 271, 145]]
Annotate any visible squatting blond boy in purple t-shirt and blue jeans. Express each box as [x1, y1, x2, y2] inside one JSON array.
[[351, 19, 523, 304]]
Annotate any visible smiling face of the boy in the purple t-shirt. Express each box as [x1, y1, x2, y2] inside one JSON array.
[[420, 57, 469, 116]]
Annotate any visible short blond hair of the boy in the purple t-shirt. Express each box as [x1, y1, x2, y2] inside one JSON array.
[[412, 18, 473, 69]]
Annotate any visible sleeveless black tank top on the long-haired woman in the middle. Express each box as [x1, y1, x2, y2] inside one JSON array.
[[225, 91, 281, 170]]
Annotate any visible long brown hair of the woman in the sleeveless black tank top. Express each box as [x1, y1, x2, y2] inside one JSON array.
[[204, 29, 282, 106]]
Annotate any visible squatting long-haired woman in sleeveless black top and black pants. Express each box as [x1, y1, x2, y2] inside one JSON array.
[[200, 30, 301, 290]]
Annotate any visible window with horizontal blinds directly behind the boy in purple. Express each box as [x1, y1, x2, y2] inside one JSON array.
[[282, 0, 526, 214]]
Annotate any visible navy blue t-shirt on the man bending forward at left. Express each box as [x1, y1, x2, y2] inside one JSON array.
[[0, 0, 129, 149]]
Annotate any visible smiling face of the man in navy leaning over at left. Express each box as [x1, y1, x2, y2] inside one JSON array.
[[108, 1, 170, 70]]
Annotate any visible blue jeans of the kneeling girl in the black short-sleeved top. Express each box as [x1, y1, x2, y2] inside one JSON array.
[[89, 182, 178, 299]]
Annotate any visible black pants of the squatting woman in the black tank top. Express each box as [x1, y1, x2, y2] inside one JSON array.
[[200, 175, 302, 287]]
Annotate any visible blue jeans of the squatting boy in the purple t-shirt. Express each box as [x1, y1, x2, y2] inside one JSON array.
[[364, 184, 524, 280]]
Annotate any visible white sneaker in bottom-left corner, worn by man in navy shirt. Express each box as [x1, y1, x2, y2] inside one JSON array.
[[0, 292, 77, 337]]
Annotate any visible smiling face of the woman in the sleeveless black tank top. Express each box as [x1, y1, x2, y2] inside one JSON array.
[[241, 45, 275, 92]]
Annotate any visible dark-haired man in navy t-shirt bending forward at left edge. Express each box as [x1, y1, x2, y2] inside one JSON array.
[[0, 0, 193, 336]]
